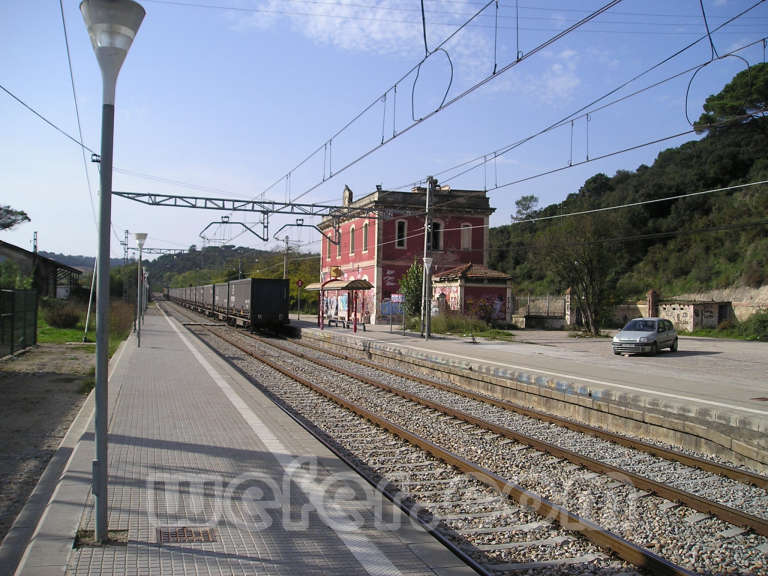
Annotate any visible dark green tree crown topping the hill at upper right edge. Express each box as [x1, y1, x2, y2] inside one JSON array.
[[695, 63, 768, 131]]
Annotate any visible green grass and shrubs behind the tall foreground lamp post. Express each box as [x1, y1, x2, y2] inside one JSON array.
[[37, 300, 134, 357]]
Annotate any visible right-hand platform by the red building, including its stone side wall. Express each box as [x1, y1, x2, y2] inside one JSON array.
[[291, 315, 768, 473]]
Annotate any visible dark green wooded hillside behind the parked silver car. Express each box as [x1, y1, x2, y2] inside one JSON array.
[[489, 64, 768, 303]]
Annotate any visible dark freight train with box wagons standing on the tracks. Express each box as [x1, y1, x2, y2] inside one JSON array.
[[166, 278, 288, 330]]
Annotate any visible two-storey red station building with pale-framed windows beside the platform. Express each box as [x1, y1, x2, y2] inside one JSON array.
[[318, 186, 511, 323]]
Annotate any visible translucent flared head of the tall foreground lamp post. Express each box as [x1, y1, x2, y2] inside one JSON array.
[[80, 0, 145, 105]]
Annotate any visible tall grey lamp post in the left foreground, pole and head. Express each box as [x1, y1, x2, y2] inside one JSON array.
[[80, 0, 144, 542]]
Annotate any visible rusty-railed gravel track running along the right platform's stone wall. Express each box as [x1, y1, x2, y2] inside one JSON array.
[[278, 342, 768, 536]]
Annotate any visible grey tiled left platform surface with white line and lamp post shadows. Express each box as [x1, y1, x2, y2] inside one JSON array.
[[4, 309, 474, 576]]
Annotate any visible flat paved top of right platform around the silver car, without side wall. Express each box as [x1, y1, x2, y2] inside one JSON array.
[[291, 315, 768, 430]]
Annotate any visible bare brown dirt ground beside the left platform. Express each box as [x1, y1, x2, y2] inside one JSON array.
[[0, 344, 94, 539]]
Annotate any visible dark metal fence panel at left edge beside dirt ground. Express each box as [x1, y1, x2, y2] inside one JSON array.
[[0, 290, 37, 357]]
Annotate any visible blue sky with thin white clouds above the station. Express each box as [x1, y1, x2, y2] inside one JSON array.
[[0, 0, 768, 257]]
